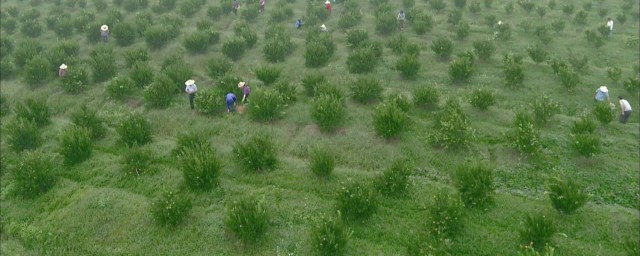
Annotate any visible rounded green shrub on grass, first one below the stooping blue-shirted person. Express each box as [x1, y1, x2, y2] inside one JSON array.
[[233, 134, 278, 172]]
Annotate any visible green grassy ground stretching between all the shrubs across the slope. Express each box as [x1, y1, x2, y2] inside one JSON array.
[[0, 0, 640, 256]]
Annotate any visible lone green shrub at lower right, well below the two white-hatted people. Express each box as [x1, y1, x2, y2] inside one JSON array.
[[549, 178, 589, 214]]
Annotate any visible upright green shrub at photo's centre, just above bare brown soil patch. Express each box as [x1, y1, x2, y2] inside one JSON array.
[[311, 93, 347, 132]]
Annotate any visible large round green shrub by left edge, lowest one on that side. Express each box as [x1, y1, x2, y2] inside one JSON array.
[[12, 150, 59, 198]]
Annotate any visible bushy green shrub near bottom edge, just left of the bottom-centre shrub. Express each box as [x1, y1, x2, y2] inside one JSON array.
[[224, 198, 269, 243]]
